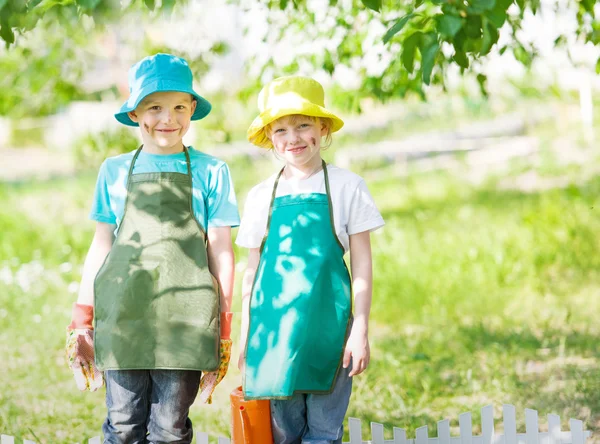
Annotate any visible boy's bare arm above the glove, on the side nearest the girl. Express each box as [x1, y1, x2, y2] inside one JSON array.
[[207, 227, 235, 313]]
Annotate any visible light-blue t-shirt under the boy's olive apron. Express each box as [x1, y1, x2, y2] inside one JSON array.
[[90, 147, 240, 230]]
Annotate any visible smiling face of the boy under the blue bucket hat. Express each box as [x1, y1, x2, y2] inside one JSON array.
[[129, 91, 196, 154]]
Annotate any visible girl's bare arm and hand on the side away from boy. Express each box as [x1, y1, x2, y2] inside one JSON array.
[[343, 231, 373, 376]]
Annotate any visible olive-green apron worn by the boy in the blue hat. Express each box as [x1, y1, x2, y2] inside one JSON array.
[[94, 147, 220, 371]]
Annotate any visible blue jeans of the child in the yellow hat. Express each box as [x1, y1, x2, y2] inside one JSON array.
[[271, 362, 352, 444]]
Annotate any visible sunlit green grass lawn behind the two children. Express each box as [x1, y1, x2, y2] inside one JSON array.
[[0, 162, 600, 443]]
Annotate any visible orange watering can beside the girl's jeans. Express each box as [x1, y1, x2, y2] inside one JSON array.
[[229, 387, 273, 444]]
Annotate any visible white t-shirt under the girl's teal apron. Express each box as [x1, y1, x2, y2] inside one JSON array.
[[235, 165, 385, 252]]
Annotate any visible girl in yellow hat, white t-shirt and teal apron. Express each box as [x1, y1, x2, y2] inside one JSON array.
[[236, 76, 384, 444]]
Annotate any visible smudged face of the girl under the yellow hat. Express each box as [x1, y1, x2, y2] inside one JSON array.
[[268, 115, 327, 170]]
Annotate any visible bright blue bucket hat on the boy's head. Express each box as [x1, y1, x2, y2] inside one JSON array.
[[115, 54, 212, 126]]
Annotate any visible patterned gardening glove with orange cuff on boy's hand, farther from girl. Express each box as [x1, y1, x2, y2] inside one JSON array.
[[66, 303, 104, 392]]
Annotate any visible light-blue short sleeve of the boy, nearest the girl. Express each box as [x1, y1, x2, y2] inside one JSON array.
[[207, 164, 240, 228]]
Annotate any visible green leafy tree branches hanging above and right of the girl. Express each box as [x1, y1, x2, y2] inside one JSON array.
[[238, 0, 600, 106]]
